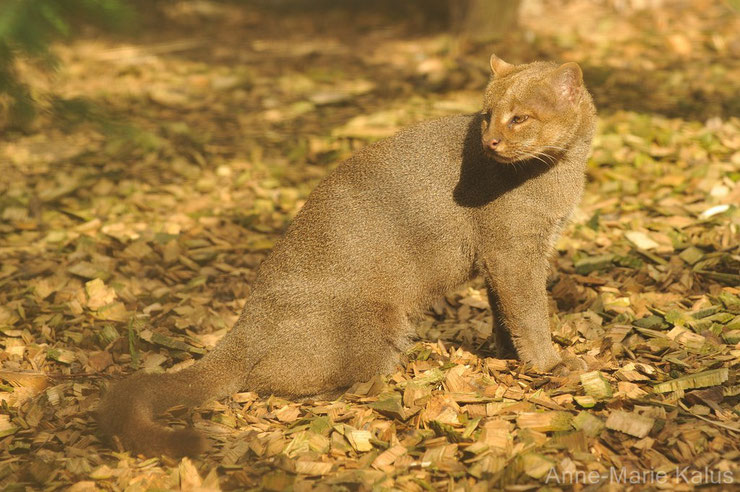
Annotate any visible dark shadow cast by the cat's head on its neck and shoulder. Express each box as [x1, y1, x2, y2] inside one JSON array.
[[453, 115, 550, 208]]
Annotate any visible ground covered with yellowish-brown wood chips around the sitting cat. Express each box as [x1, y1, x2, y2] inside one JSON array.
[[0, 0, 740, 491]]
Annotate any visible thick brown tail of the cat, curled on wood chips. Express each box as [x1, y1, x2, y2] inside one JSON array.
[[97, 336, 249, 458]]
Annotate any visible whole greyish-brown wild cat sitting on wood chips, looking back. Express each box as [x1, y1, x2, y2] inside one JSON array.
[[99, 56, 595, 456]]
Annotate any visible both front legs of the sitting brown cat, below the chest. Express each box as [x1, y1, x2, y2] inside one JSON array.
[[483, 245, 561, 371]]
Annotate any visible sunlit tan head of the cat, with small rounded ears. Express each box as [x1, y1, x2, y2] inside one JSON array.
[[481, 55, 594, 164]]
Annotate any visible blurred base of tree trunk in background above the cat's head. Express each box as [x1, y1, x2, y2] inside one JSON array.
[[449, 0, 522, 42]]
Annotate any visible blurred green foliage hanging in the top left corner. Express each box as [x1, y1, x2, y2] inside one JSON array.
[[0, 0, 133, 128]]
